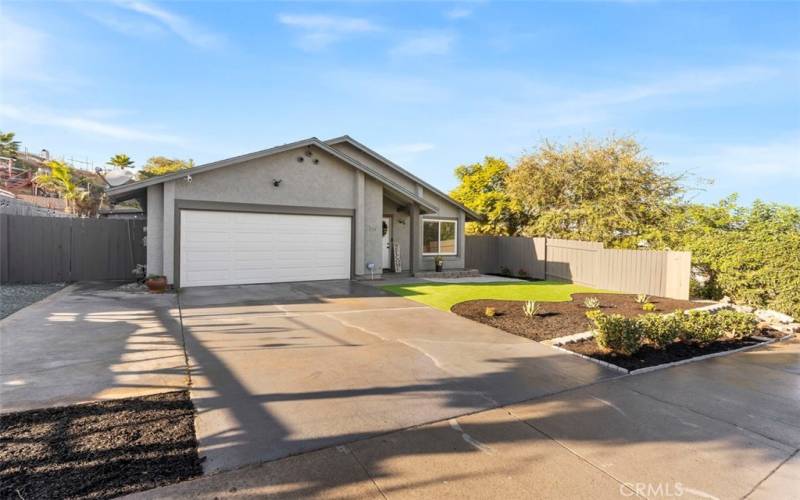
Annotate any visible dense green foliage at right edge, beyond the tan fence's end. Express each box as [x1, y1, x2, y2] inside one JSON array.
[[665, 195, 800, 317]]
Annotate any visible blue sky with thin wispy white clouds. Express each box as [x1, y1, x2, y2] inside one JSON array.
[[0, 0, 800, 205]]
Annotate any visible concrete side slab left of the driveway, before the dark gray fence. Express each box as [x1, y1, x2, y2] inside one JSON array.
[[0, 283, 187, 412]]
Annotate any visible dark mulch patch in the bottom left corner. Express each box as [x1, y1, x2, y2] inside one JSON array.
[[0, 391, 202, 499]]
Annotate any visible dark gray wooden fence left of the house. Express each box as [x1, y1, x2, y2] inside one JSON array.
[[0, 215, 146, 283]]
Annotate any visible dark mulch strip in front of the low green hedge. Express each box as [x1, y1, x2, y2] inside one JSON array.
[[561, 338, 761, 370]]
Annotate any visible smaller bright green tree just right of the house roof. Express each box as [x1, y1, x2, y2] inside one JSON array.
[[450, 156, 523, 236]]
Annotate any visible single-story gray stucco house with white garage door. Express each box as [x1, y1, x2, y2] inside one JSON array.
[[108, 136, 479, 286]]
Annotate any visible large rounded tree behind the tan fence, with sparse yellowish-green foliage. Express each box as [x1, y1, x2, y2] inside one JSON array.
[[507, 137, 683, 248]]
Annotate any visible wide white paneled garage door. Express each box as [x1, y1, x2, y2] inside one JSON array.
[[180, 210, 350, 286]]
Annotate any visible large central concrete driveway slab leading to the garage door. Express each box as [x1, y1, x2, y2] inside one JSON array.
[[179, 281, 616, 472]]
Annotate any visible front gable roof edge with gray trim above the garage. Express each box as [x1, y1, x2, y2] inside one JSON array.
[[106, 137, 439, 212]]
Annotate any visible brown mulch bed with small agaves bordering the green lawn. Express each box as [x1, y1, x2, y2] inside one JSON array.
[[451, 293, 700, 340]]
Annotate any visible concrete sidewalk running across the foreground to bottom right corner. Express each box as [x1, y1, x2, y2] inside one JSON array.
[[128, 340, 800, 500]]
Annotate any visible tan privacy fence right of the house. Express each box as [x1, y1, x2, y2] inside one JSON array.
[[465, 236, 692, 299]]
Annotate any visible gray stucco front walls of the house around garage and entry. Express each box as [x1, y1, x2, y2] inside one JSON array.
[[147, 145, 464, 283]]
